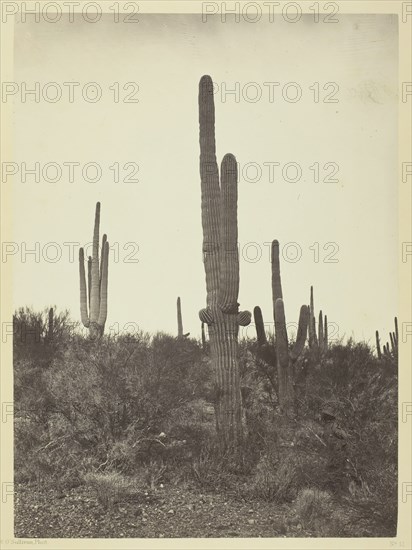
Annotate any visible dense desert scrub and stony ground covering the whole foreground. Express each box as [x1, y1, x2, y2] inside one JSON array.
[[14, 308, 397, 537]]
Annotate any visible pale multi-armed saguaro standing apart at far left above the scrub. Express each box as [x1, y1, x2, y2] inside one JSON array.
[[79, 202, 109, 339]]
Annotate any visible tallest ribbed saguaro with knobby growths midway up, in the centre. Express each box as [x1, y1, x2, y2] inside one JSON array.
[[199, 76, 251, 449]]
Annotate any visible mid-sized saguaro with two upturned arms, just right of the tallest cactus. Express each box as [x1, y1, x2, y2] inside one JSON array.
[[254, 240, 310, 414]]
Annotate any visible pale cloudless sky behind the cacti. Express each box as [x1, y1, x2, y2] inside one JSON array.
[[9, 15, 398, 343]]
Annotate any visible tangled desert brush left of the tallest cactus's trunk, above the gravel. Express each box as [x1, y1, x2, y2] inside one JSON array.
[[14, 310, 208, 483]]
